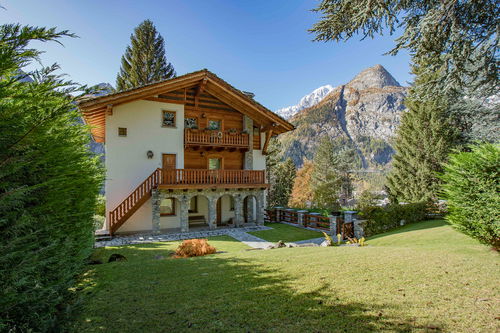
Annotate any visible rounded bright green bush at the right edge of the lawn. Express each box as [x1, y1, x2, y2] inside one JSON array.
[[441, 144, 500, 249]]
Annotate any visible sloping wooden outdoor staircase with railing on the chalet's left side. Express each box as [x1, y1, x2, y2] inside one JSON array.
[[109, 169, 161, 235]]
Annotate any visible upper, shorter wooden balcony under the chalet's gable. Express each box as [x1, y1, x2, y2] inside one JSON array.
[[184, 128, 250, 150]]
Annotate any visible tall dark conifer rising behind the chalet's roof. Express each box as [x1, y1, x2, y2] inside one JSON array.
[[116, 20, 176, 91]]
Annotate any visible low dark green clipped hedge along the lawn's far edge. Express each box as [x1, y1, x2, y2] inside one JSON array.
[[358, 202, 427, 236]]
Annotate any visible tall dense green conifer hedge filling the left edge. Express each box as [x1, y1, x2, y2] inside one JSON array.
[[0, 25, 102, 332]]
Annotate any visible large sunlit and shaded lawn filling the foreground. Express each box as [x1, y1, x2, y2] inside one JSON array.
[[74, 221, 500, 332]]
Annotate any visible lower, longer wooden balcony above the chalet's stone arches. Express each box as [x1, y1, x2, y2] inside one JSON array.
[[159, 169, 268, 189]]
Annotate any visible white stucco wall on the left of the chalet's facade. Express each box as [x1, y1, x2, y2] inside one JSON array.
[[105, 100, 184, 232]]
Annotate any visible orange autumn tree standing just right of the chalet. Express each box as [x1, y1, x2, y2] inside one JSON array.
[[288, 160, 314, 208]]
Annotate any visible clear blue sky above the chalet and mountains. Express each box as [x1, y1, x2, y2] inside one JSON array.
[[0, 0, 411, 110]]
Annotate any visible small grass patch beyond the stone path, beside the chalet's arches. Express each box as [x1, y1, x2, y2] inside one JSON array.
[[249, 223, 323, 242]]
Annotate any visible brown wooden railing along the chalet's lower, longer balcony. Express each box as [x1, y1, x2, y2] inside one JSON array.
[[161, 169, 266, 185]]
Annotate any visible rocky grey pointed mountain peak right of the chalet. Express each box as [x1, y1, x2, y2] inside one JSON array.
[[279, 65, 408, 169]]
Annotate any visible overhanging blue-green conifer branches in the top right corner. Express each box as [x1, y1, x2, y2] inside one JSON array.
[[311, 0, 500, 97]]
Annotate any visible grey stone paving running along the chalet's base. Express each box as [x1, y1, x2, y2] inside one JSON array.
[[94, 226, 272, 248]]
